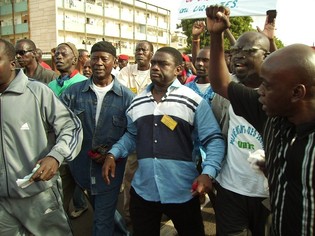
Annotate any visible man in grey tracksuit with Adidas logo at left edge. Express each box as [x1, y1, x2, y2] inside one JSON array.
[[0, 39, 83, 235]]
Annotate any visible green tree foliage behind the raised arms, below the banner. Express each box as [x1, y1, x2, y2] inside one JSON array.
[[177, 16, 284, 54]]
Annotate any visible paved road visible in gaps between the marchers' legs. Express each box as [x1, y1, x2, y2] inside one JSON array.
[[71, 194, 215, 236]]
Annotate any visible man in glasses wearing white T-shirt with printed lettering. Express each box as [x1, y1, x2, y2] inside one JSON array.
[[209, 10, 274, 236]]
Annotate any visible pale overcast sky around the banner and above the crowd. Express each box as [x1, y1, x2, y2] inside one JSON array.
[[144, 0, 315, 46]]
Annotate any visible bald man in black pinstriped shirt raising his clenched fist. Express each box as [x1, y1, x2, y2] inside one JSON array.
[[206, 5, 315, 236]]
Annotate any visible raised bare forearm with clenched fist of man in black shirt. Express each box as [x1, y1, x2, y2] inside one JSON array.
[[206, 5, 230, 99]]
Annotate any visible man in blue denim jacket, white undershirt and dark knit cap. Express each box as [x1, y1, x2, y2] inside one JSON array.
[[61, 41, 134, 235]]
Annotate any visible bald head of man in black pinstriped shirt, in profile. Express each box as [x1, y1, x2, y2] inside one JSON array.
[[258, 44, 315, 121]]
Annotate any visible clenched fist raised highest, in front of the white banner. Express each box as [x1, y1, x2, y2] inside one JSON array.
[[206, 5, 231, 34]]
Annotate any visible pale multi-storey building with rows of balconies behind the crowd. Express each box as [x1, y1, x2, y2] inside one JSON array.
[[0, 0, 171, 58]]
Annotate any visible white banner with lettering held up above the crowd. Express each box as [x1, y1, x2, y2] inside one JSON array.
[[178, 0, 277, 20]]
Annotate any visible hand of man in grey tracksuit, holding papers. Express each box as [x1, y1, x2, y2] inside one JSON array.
[[31, 156, 59, 181]]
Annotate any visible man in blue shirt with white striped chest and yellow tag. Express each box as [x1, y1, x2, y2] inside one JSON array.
[[103, 47, 225, 236]]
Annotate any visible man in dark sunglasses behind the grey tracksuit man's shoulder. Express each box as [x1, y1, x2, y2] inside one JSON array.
[[15, 39, 58, 84]]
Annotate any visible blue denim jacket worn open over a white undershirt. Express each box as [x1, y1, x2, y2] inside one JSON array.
[[61, 78, 134, 194]]
